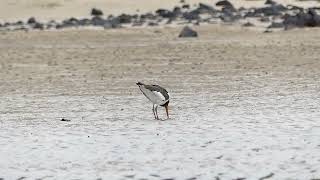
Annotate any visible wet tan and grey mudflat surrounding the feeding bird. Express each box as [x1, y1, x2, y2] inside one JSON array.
[[0, 26, 320, 179]]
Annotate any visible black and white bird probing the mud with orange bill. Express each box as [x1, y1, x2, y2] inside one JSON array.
[[136, 82, 170, 120]]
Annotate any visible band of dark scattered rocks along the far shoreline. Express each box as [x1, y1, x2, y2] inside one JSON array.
[[0, 0, 320, 32]]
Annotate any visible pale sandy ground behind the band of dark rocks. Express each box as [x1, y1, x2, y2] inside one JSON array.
[[0, 0, 320, 22]]
